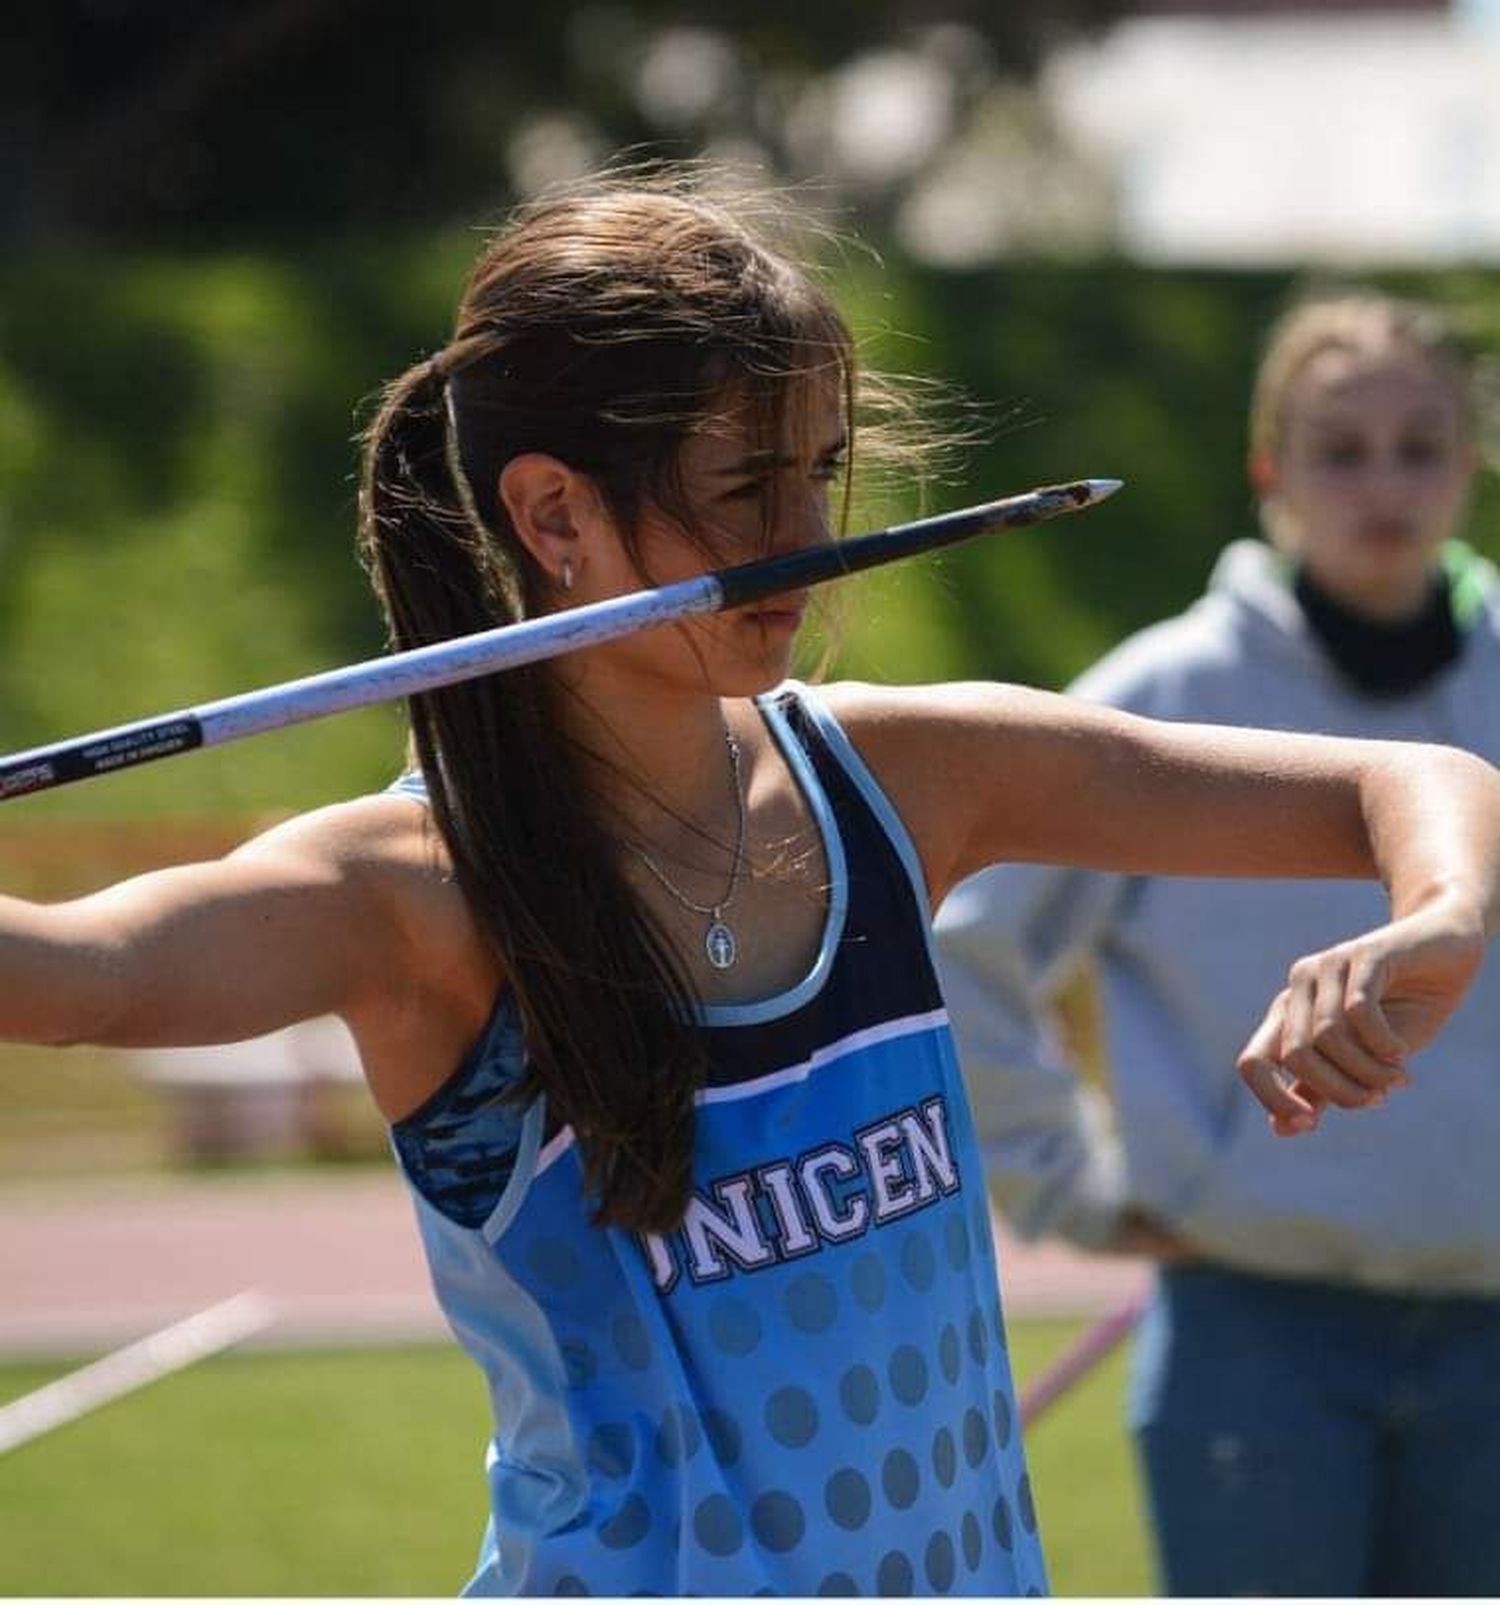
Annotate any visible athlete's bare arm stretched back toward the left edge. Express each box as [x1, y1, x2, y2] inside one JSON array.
[[0, 798, 497, 1091]]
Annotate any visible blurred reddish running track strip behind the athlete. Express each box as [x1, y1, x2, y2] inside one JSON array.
[[0, 1172, 1147, 1358]]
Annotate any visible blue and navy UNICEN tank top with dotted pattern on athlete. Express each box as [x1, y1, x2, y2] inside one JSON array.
[[393, 687, 1046, 1595]]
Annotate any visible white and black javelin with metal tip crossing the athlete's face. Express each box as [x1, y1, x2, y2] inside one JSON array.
[[0, 480, 1120, 801]]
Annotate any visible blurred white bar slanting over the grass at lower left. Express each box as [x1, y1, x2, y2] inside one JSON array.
[[0, 1289, 276, 1454]]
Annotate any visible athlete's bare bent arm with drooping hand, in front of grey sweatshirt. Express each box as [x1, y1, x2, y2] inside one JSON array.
[[833, 685, 1500, 1135]]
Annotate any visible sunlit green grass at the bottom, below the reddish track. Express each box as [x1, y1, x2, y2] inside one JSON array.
[[0, 1323, 1150, 1595]]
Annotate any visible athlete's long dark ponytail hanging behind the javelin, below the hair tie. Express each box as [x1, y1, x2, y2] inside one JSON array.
[[361, 363, 703, 1231]]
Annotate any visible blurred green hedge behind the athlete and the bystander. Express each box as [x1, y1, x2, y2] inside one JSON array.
[[0, 243, 1500, 812]]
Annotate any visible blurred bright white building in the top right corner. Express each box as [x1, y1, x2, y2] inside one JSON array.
[[1041, 0, 1500, 266]]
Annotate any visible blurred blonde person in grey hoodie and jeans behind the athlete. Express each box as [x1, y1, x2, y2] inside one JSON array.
[[939, 292, 1500, 1595]]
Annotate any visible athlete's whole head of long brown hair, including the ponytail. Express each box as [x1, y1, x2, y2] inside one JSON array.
[[361, 175, 855, 1229]]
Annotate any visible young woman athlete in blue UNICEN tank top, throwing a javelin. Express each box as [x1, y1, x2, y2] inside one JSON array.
[[0, 181, 1500, 1595]]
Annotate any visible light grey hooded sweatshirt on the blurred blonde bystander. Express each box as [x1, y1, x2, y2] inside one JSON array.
[[937, 541, 1500, 1294]]
